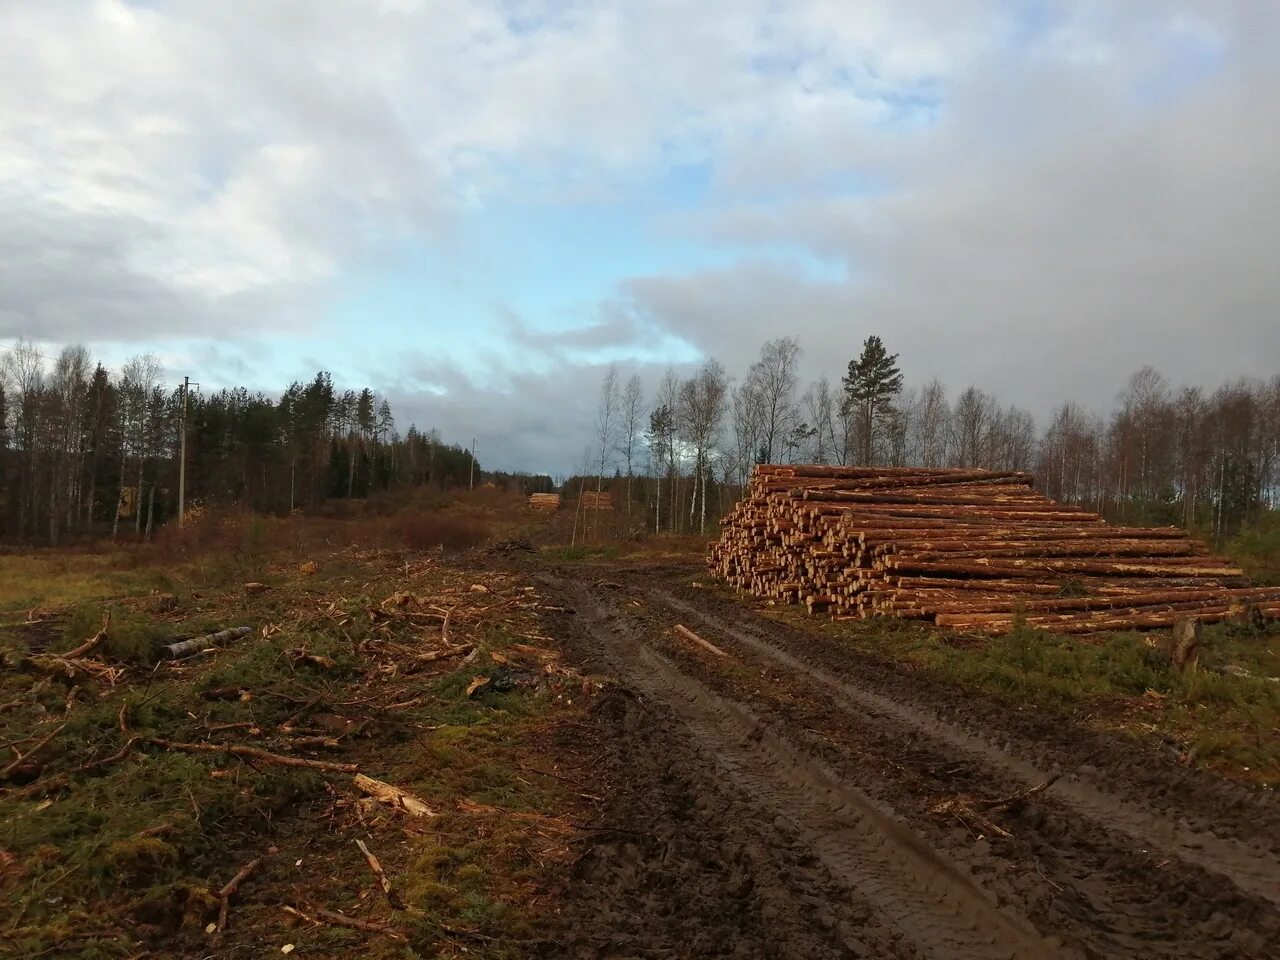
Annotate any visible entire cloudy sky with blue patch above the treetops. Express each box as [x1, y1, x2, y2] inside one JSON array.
[[0, 0, 1280, 474]]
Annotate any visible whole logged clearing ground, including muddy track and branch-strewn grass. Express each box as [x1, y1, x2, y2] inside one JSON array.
[[0, 529, 1280, 959]]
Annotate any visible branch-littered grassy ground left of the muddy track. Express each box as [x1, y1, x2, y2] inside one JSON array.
[[0, 537, 593, 959]]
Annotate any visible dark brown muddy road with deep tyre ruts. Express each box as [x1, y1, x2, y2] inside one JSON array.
[[538, 567, 1280, 959]]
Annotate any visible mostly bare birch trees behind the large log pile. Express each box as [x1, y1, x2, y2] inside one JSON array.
[[591, 335, 1280, 539]]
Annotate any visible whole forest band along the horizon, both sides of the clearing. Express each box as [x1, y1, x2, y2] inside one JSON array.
[[0, 335, 1280, 544]]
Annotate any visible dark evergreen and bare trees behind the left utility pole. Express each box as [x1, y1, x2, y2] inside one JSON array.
[[0, 340, 481, 544]]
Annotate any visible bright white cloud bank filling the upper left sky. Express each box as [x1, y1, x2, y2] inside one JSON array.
[[0, 0, 988, 338]]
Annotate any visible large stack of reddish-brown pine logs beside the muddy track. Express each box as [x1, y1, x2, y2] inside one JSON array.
[[708, 465, 1280, 634]]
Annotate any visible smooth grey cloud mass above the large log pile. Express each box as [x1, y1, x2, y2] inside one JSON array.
[[627, 0, 1280, 415]]
